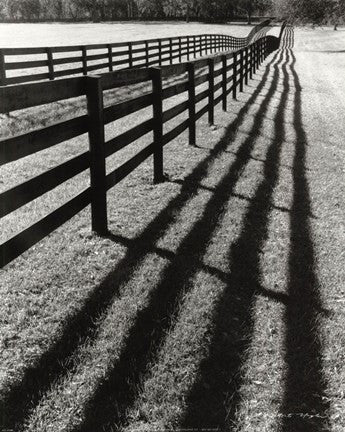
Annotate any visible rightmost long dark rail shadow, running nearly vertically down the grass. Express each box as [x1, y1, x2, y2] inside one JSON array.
[[281, 52, 330, 432]]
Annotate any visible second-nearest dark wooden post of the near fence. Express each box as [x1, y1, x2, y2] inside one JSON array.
[[151, 68, 164, 183]]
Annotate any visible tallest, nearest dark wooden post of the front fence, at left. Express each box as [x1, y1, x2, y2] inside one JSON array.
[[86, 76, 108, 235]]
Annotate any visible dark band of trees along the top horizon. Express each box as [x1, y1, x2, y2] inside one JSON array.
[[0, 0, 345, 25]]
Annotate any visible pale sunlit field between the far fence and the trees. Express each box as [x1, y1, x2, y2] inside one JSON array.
[[0, 22, 274, 82]]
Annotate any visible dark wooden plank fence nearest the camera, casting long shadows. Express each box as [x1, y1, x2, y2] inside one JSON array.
[[0, 27, 280, 267]]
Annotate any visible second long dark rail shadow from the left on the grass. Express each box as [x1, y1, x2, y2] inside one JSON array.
[[69, 49, 278, 431]]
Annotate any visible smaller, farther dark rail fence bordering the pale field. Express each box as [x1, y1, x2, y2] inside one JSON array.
[[0, 20, 271, 86]]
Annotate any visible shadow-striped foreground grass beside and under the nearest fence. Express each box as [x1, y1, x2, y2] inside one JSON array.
[[0, 25, 345, 432]]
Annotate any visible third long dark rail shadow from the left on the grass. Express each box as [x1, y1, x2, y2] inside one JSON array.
[[182, 50, 290, 430]]
